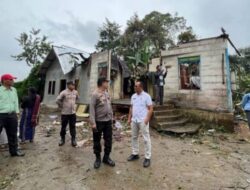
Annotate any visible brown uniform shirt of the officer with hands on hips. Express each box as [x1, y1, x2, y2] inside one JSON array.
[[56, 89, 78, 115]]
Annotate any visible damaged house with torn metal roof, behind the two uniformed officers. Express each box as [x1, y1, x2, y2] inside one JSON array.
[[40, 46, 130, 106]]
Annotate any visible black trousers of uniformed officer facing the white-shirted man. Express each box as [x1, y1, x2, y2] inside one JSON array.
[[93, 120, 112, 156]]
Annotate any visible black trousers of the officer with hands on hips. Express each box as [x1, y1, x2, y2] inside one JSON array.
[[60, 114, 76, 139]]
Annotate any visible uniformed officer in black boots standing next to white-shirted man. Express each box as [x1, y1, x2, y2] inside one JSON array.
[[89, 78, 115, 169]]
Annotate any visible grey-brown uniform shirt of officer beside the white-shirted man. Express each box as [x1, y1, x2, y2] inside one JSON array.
[[89, 89, 113, 125]]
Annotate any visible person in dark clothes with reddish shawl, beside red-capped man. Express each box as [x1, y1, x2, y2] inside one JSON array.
[[19, 87, 41, 142]]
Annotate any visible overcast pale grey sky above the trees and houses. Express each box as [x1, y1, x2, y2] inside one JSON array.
[[0, 0, 250, 80]]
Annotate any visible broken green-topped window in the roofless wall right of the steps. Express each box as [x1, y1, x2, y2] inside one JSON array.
[[178, 56, 201, 90]]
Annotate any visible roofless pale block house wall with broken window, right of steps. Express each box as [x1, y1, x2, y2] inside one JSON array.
[[149, 34, 237, 127]]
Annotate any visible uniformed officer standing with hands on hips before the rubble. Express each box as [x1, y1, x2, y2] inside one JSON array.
[[56, 81, 79, 147]]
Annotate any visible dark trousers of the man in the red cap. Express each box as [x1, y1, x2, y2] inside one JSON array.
[[0, 113, 18, 155]]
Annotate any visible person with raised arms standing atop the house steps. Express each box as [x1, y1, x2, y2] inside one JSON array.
[[155, 65, 167, 105]]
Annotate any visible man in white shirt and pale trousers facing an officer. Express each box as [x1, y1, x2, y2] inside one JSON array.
[[128, 81, 153, 167]]
